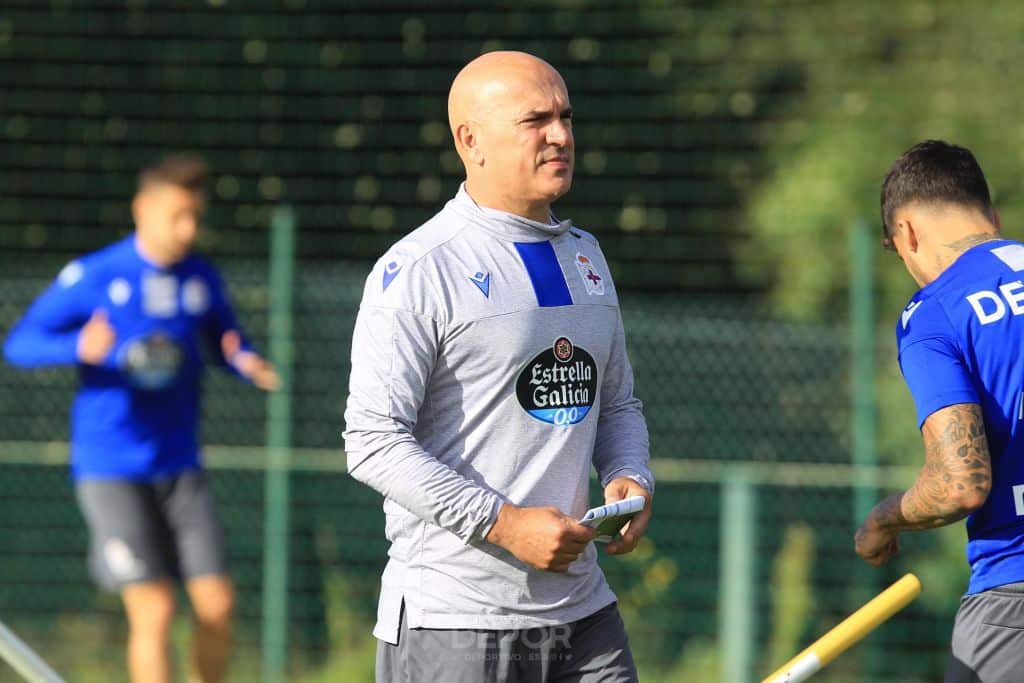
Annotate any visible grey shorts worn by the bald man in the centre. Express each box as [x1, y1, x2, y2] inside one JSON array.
[[377, 603, 637, 683]]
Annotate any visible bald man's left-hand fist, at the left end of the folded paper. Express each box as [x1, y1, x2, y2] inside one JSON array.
[[487, 503, 597, 571]]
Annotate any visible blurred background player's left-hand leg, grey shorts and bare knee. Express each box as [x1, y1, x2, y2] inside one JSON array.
[[75, 480, 175, 683]]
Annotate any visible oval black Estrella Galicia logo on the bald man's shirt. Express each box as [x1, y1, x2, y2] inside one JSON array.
[[515, 337, 597, 427]]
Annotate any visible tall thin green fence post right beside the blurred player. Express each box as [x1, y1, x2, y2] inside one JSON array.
[[262, 205, 295, 683]]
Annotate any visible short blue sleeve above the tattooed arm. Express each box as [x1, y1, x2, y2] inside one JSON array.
[[897, 300, 980, 427]]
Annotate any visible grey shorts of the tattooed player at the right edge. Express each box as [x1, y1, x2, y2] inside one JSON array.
[[944, 583, 1024, 683]]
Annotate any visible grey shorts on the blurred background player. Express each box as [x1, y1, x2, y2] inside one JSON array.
[[75, 471, 227, 591]]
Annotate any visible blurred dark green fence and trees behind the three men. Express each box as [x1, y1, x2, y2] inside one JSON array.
[[0, 0, 1024, 683]]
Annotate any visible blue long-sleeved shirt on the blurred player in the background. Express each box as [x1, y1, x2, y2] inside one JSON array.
[[4, 238, 248, 481]]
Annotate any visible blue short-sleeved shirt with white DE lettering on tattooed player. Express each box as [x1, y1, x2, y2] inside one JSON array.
[[896, 240, 1024, 594]]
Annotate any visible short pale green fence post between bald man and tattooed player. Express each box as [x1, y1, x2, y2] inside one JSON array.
[[718, 465, 757, 683]]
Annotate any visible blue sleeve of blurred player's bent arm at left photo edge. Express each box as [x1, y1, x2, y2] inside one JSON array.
[[4, 261, 96, 368]]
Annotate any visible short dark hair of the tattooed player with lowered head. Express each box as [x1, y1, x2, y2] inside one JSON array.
[[882, 140, 992, 247]]
